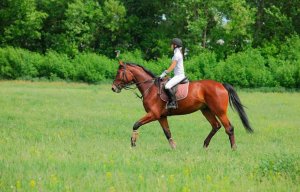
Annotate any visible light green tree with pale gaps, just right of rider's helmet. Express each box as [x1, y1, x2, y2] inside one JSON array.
[[182, 0, 255, 59]]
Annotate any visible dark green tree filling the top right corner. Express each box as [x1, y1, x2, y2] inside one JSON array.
[[247, 0, 300, 47]]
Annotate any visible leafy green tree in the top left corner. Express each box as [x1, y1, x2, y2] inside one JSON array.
[[0, 0, 47, 50]]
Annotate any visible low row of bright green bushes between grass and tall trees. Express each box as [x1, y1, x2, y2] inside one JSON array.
[[0, 36, 300, 88]]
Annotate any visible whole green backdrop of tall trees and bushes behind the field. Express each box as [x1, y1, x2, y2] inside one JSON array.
[[0, 0, 300, 88]]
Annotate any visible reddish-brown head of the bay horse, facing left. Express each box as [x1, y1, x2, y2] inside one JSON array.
[[111, 61, 134, 93]]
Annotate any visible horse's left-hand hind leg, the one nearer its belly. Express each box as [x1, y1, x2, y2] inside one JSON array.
[[201, 108, 221, 148]]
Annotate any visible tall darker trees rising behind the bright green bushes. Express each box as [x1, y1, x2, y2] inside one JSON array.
[[0, 0, 300, 60]]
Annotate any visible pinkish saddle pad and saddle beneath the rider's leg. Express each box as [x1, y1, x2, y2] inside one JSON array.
[[158, 77, 189, 102]]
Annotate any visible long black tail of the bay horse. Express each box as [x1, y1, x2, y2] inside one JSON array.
[[223, 83, 254, 133]]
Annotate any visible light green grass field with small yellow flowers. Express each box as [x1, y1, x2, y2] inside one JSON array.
[[0, 81, 300, 192]]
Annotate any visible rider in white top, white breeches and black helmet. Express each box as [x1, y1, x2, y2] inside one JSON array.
[[160, 38, 185, 109]]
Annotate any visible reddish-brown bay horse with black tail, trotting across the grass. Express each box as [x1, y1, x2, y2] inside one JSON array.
[[112, 61, 253, 150]]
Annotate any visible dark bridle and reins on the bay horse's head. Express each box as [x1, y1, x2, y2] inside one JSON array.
[[113, 63, 156, 99]]
